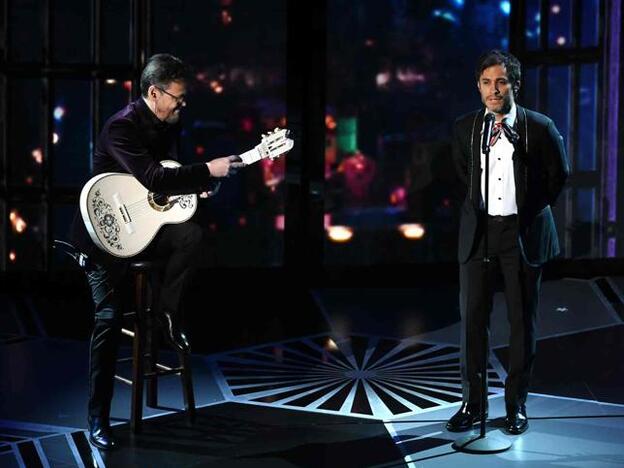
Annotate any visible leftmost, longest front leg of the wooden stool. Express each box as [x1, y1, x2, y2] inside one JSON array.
[[130, 273, 145, 433]]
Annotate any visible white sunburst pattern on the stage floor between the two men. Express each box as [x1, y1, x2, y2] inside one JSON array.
[[210, 334, 505, 420]]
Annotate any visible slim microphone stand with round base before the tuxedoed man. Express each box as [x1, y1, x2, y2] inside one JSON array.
[[452, 113, 512, 454]]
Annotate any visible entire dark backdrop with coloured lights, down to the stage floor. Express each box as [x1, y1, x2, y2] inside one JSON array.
[[0, 0, 624, 350]]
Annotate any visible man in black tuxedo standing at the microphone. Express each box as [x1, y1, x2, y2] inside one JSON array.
[[447, 50, 569, 434]]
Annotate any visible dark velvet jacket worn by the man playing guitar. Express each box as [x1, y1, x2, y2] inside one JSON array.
[[70, 98, 214, 255]]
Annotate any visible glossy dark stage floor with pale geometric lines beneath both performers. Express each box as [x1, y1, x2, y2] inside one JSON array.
[[0, 278, 624, 468]]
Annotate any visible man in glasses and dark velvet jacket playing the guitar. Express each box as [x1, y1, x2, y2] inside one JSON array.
[[72, 54, 244, 449]]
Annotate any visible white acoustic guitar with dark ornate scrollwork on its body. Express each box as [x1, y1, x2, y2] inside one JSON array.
[[80, 128, 294, 258]]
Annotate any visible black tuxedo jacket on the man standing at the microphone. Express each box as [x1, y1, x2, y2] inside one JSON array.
[[453, 105, 570, 266]]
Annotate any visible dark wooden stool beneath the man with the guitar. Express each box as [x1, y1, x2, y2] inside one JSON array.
[[115, 260, 195, 433]]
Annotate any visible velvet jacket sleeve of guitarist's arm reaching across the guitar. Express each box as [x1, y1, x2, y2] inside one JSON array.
[[106, 119, 211, 194]]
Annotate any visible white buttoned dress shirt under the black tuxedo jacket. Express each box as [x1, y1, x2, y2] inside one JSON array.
[[481, 103, 518, 216]]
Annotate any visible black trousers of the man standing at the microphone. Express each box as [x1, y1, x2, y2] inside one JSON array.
[[459, 216, 541, 410]]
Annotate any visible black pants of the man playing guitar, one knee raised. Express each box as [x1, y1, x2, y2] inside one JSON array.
[[87, 222, 202, 420]]
